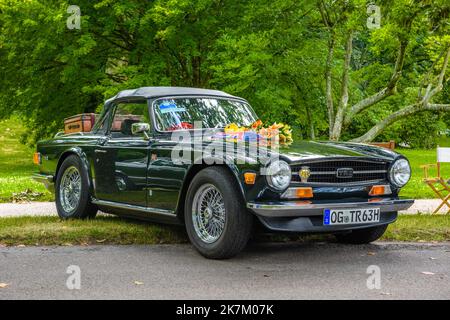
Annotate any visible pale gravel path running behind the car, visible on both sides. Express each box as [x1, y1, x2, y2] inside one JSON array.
[[0, 199, 448, 217]]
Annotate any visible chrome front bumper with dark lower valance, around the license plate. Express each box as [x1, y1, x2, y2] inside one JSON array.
[[247, 198, 414, 233]]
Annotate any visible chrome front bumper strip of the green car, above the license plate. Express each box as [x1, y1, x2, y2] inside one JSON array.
[[247, 198, 414, 218]]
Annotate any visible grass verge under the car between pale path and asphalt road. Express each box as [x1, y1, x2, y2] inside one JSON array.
[[0, 215, 450, 246]]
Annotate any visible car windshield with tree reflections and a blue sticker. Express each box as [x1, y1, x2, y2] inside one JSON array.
[[154, 98, 258, 131]]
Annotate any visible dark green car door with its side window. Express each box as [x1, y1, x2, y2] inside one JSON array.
[[94, 100, 150, 207]]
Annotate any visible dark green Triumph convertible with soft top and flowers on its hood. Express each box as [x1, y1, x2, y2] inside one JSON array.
[[33, 87, 413, 259]]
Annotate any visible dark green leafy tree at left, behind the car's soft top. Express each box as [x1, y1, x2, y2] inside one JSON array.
[[0, 0, 246, 142]]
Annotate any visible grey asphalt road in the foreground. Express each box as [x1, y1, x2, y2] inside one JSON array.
[[0, 243, 450, 299]]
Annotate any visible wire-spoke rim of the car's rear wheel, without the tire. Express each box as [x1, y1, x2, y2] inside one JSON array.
[[59, 166, 81, 214]]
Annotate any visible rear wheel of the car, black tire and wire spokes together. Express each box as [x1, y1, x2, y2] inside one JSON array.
[[55, 155, 98, 219]]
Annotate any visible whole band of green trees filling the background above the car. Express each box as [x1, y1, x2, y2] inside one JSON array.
[[0, 0, 450, 146]]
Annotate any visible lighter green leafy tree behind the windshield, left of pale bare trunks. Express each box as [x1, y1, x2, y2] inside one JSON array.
[[210, 0, 327, 139]]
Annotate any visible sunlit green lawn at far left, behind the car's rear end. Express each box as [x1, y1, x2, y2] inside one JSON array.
[[0, 119, 53, 202]]
